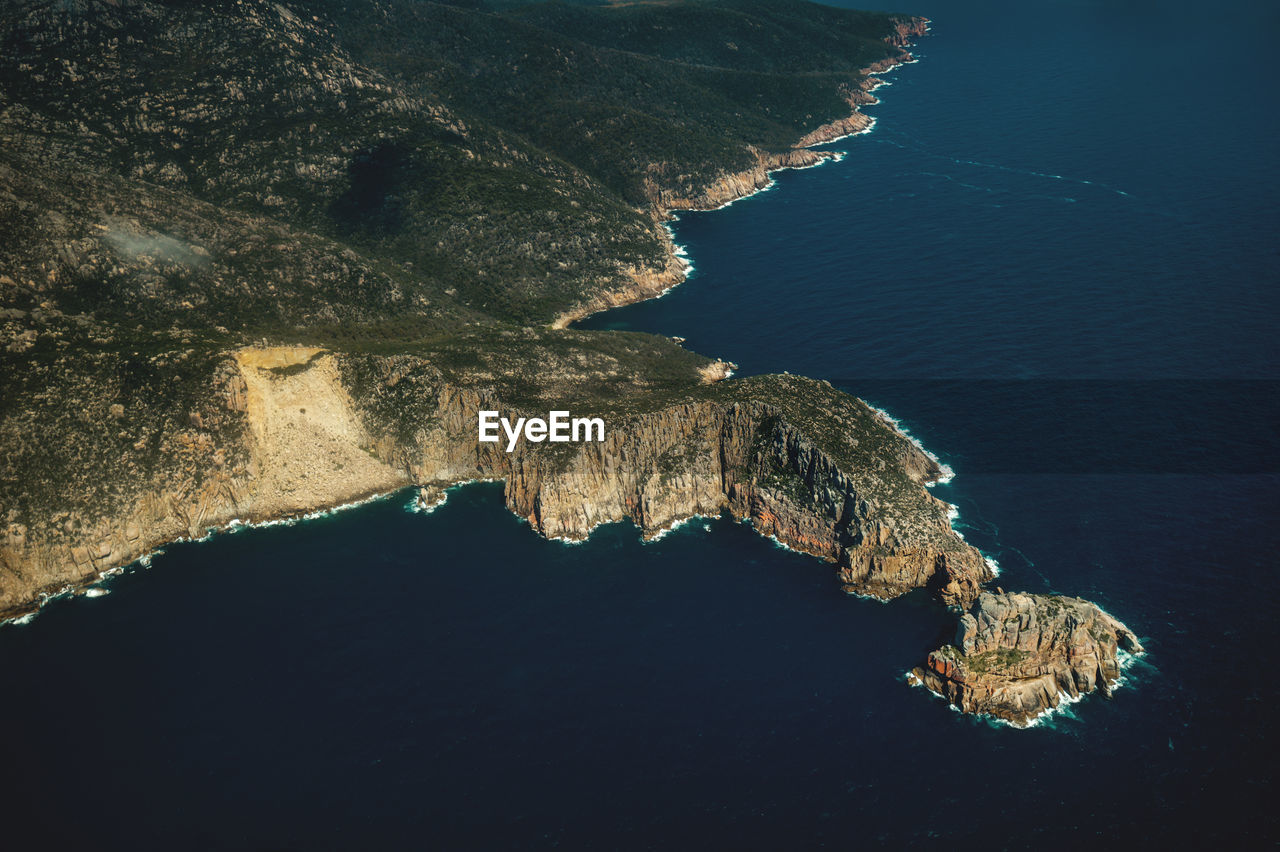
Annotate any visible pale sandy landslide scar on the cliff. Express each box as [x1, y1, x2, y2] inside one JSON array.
[[236, 347, 408, 517]]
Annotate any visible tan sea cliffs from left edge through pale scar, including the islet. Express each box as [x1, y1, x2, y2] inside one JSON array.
[[0, 331, 1142, 724]]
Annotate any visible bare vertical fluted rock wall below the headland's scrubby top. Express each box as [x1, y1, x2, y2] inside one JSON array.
[[486, 402, 992, 605]]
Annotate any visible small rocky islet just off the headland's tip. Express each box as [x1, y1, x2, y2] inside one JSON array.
[[911, 591, 1143, 725]]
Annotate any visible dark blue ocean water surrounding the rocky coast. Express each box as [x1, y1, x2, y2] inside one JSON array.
[[0, 0, 1280, 849]]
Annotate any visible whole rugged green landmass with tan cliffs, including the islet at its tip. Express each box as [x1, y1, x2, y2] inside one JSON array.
[[0, 0, 1140, 724]]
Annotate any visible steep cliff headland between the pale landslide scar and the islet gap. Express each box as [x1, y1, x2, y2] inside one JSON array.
[[355, 358, 992, 604]]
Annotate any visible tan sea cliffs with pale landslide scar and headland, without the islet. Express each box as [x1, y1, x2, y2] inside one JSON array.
[[0, 347, 991, 617]]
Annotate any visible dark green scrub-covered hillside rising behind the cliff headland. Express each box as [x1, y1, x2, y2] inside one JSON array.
[[0, 0, 911, 336]]
